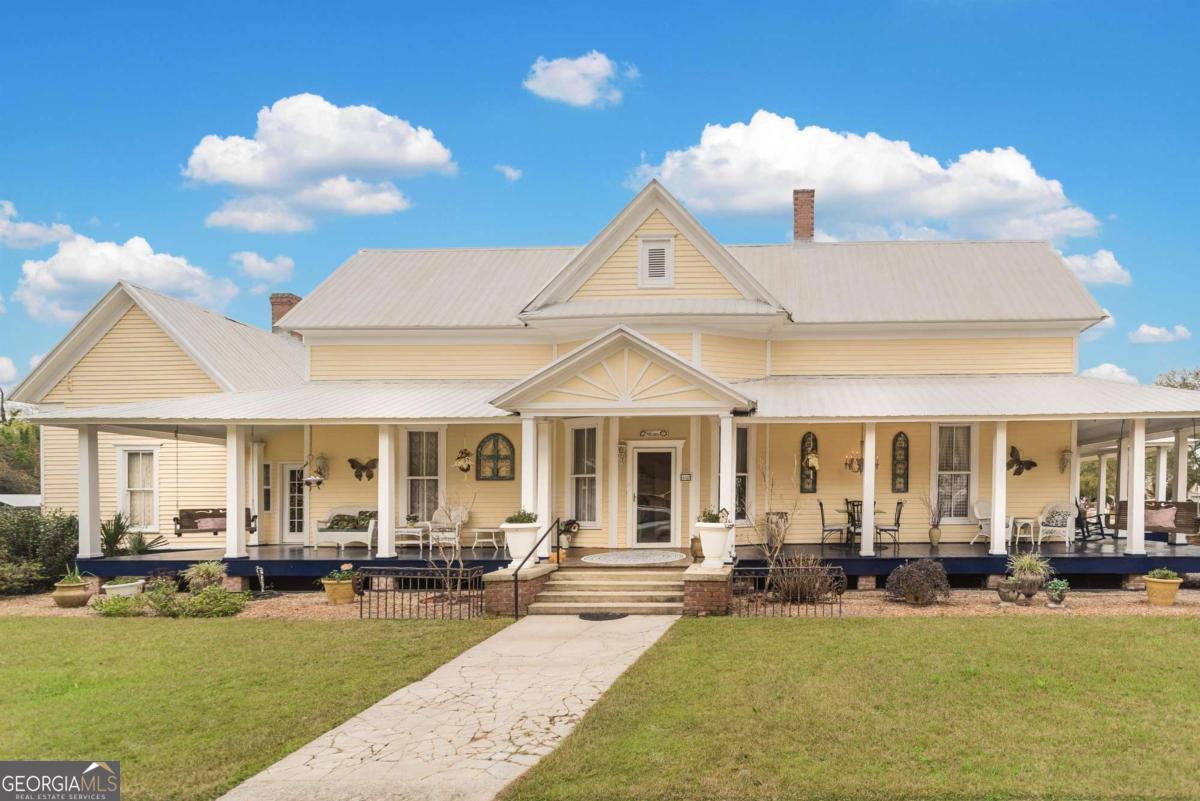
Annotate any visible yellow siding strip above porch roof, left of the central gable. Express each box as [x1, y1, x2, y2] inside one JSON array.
[[310, 344, 551, 380]]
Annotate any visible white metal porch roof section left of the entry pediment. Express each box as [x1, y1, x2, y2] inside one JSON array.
[[30, 380, 512, 426]]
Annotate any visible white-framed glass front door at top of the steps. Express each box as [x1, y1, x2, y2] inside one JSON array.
[[629, 445, 679, 548]]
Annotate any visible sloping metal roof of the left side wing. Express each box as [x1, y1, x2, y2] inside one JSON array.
[[124, 283, 308, 392]]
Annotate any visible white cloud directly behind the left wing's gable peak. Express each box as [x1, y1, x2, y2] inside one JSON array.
[[12, 235, 238, 323]]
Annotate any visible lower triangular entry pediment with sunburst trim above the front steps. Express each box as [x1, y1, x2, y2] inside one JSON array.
[[492, 326, 754, 414]]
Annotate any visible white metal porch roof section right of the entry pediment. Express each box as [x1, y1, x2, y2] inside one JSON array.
[[732, 374, 1200, 420]]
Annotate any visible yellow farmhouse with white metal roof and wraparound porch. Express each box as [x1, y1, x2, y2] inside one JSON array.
[[14, 182, 1200, 606]]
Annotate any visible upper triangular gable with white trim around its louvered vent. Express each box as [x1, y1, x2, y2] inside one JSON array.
[[526, 181, 780, 312]]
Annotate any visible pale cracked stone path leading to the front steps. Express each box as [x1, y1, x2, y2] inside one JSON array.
[[222, 615, 676, 801]]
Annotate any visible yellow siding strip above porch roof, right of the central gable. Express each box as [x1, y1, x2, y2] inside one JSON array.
[[770, 337, 1075, 375]]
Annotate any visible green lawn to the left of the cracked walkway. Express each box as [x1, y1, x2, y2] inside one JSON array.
[[0, 618, 505, 801]]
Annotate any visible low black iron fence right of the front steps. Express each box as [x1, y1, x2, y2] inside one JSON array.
[[731, 565, 846, 618]]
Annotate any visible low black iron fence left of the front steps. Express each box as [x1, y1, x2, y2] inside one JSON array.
[[354, 562, 484, 620]]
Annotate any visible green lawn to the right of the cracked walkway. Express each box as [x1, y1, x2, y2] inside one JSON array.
[[504, 618, 1200, 801]]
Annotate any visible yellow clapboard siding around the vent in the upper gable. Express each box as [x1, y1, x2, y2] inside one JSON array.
[[571, 211, 742, 300]]
